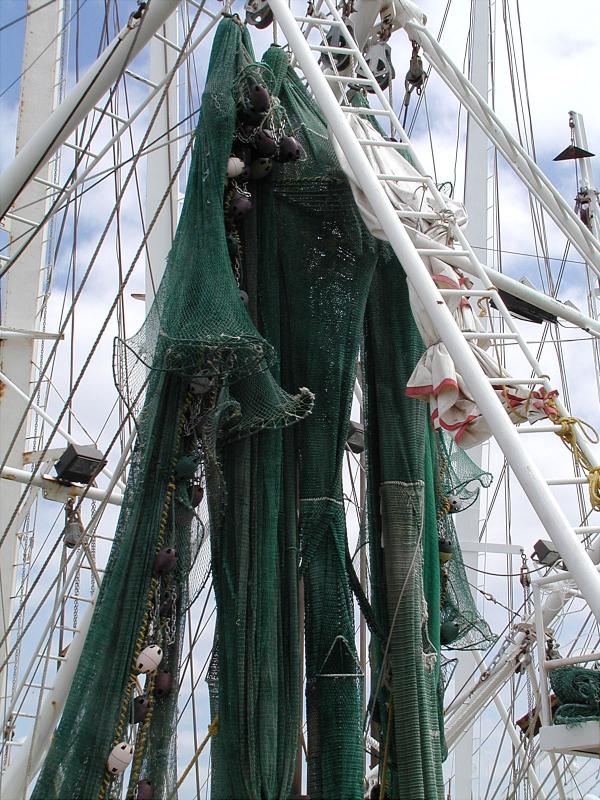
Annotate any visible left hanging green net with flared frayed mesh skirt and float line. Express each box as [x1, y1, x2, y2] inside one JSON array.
[[33, 19, 312, 800]]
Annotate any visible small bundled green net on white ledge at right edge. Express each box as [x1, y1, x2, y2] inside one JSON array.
[[548, 667, 600, 725]]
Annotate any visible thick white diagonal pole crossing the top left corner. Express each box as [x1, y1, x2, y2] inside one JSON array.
[[0, 0, 180, 218]]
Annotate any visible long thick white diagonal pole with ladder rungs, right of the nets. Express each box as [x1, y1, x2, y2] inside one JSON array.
[[270, 0, 600, 622]]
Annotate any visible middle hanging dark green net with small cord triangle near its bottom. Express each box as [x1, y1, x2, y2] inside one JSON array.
[[243, 47, 378, 800]]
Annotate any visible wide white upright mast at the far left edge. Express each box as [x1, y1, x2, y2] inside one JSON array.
[[0, 0, 64, 732]]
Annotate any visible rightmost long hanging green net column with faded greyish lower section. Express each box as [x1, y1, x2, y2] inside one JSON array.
[[365, 247, 443, 800]]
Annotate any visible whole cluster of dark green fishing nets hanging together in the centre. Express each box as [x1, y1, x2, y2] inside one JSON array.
[[33, 18, 496, 800]]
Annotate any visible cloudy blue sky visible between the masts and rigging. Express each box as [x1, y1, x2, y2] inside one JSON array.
[[0, 0, 600, 796]]
